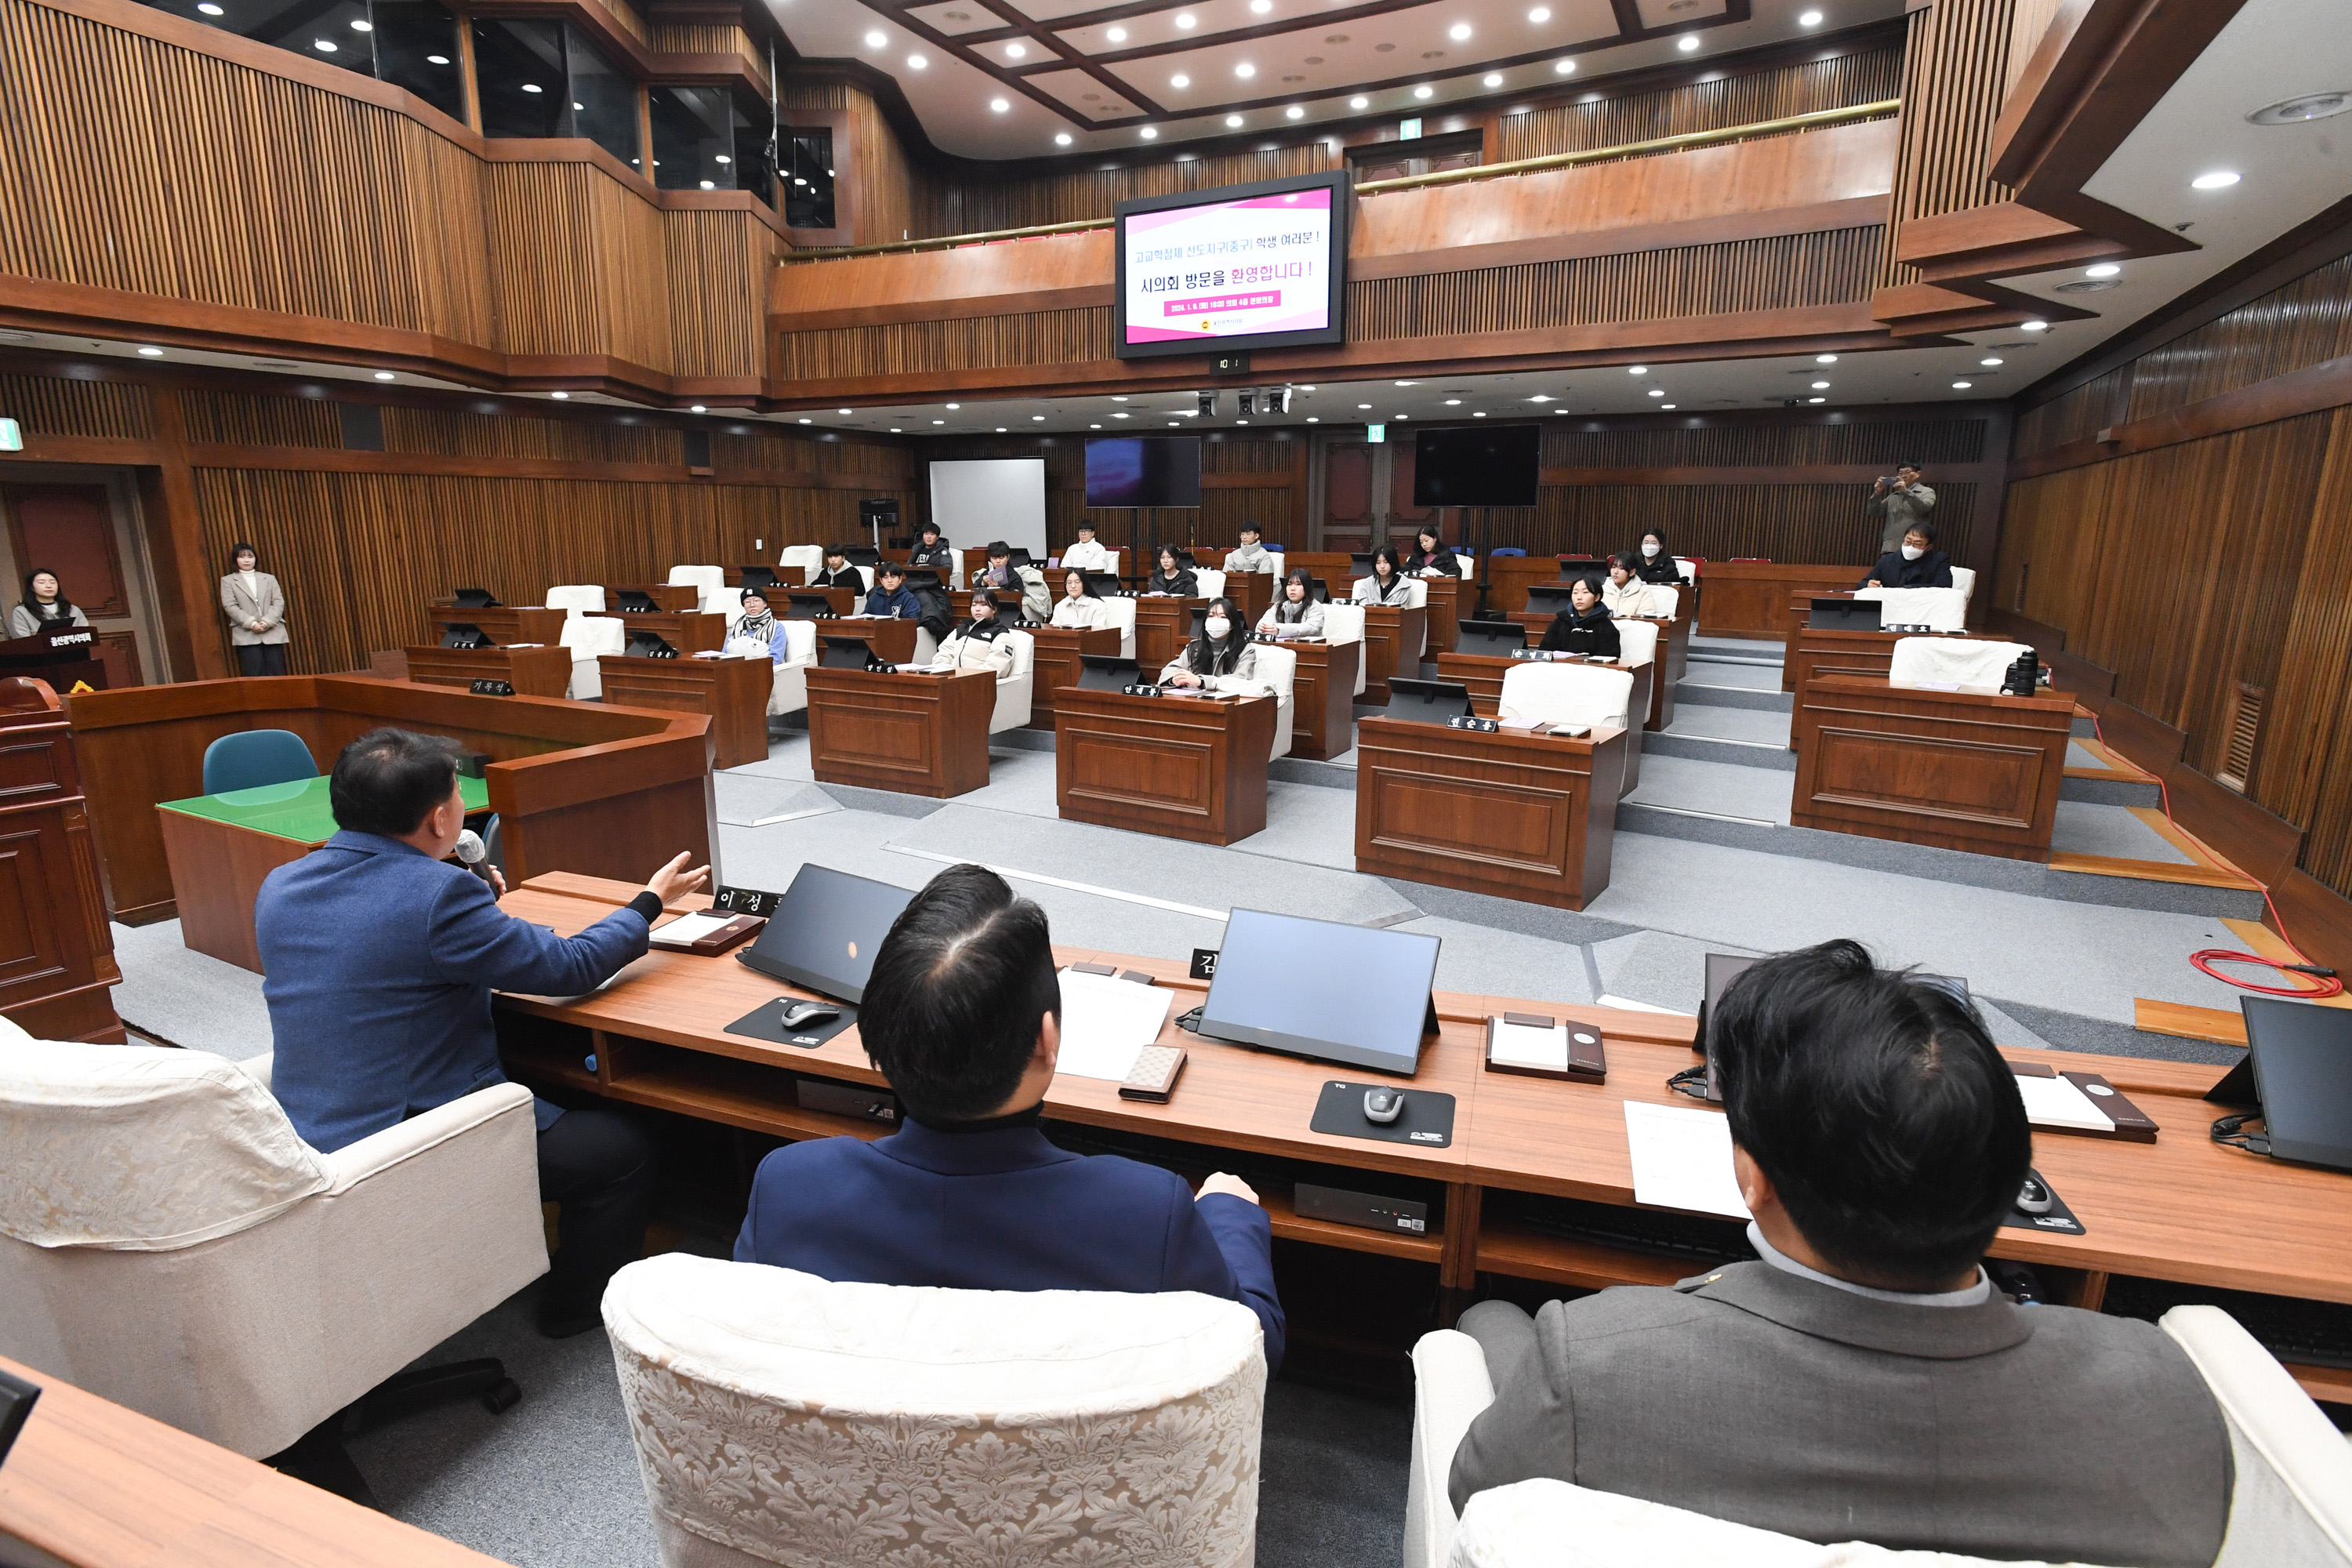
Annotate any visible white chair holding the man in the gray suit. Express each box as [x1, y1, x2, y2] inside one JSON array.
[[1404, 1307, 2352, 1568]]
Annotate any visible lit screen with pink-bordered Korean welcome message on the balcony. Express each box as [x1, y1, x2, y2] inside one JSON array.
[[1115, 174, 1355, 360]]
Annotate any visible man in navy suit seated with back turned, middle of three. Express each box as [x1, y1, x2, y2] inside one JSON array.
[[736, 865, 1282, 1370]]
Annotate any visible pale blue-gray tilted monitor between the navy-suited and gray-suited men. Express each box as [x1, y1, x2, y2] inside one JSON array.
[[1200, 909, 1437, 1076]]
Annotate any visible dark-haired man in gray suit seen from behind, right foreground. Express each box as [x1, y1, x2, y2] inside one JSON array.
[[1449, 940, 2230, 1568]]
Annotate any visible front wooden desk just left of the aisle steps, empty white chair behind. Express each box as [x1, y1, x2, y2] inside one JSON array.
[[1355, 717, 1630, 909]]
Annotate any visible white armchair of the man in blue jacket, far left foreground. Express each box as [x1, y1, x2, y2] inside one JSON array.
[[0, 1022, 548, 1457]]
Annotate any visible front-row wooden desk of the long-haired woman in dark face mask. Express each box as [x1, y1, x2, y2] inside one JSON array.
[[1054, 687, 1296, 844]]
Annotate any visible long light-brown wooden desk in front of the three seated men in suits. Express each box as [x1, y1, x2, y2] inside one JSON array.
[[496, 874, 2352, 1399]]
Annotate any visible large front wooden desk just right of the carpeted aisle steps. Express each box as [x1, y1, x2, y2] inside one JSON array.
[[1790, 675, 2070, 865]]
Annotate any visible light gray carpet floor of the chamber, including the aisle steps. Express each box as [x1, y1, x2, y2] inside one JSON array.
[[101, 640, 2267, 1568]]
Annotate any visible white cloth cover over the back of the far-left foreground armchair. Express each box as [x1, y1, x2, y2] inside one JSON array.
[[0, 1044, 334, 1253]]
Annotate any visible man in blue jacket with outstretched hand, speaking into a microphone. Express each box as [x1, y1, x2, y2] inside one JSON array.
[[254, 729, 710, 1338]]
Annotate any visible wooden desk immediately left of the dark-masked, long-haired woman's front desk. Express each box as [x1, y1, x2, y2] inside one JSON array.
[[809, 667, 997, 797]]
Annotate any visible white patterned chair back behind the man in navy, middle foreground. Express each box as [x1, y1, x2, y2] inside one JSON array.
[[604, 1253, 1265, 1568]]
